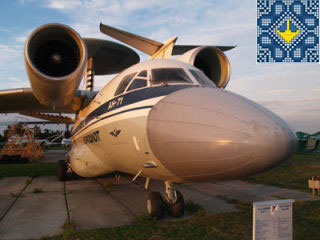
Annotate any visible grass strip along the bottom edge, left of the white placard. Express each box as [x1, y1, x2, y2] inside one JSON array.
[[42, 209, 251, 240]]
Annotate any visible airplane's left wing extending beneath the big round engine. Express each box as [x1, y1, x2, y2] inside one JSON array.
[[0, 88, 97, 124]]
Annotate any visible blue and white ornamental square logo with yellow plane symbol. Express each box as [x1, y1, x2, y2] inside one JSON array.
[[257, 0, 319, 63]]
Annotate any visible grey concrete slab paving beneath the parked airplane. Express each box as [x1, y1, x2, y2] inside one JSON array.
[[0, 151, 313, 240]]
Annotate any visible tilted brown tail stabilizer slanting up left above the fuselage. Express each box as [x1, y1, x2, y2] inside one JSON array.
[[100, 23, 163, 56]]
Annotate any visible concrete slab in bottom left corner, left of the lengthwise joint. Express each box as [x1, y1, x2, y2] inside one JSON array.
[[0, 177, 67, 239]]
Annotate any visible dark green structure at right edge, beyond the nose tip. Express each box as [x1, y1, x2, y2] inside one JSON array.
[[296, 131, 320, 153]]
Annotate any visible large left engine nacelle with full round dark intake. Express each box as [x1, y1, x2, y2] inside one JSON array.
[[24, 24, 87, 108]]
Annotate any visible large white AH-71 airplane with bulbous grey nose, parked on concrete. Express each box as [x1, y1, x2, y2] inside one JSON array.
[[0, 23, 296, 219]]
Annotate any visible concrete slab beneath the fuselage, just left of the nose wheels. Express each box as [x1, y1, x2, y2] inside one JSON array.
[[66, 179, 135, 230]]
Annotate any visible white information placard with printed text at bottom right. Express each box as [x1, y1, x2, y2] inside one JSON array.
[[253, 199, 294, 240]]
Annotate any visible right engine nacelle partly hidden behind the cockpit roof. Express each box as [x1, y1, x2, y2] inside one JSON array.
[[178, 47, 230, 88]]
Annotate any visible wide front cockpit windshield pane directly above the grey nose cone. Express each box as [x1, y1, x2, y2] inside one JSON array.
[[151, 68, 192, 84]]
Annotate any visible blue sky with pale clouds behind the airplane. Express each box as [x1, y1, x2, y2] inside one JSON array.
[[0, 0, 320, 133]]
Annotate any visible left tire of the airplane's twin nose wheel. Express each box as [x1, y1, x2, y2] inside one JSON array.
[[147, 192, 164, 219]]
